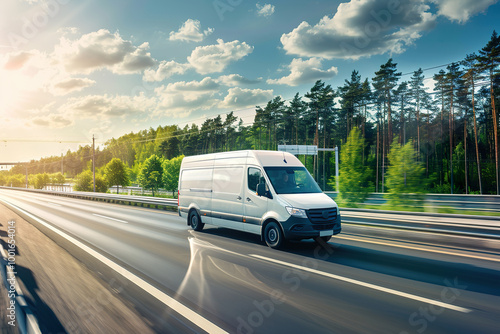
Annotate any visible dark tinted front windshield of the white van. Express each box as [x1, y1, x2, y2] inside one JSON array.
[[264, 167, 321, 194]]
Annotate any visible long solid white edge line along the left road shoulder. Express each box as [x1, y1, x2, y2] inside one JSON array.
[[0, 199, 229, 334]]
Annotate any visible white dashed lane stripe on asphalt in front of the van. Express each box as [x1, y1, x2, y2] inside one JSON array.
[[250, 254, 472, 313]]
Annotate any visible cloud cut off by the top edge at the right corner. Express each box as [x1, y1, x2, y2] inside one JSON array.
[[431, 0, 498, 23]]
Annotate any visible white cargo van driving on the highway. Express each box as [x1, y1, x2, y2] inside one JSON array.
[[178, 151, 341, 248]]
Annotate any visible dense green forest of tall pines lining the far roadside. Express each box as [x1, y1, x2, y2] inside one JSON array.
[[0, 31, 500, 194]]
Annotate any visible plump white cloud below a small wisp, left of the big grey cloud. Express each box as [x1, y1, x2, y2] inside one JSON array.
[[187, 39, 253, 74]]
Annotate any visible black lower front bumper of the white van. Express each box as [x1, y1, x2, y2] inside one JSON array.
[[281, 215, 342, 240]]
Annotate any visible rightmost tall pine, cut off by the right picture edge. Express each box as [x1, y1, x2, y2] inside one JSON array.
[[479, 31, 500, 195]]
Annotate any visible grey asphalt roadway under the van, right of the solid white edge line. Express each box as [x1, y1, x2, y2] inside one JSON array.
[[0, 190, 500, 333]]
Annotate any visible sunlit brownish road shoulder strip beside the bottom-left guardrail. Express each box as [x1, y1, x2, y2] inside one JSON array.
[[0, 205, 153, 333]]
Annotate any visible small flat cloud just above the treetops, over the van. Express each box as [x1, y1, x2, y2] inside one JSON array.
[[219, 87, 273, 109]]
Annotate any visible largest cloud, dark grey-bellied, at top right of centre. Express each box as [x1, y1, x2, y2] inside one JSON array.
[[281, 0, 436, 59]]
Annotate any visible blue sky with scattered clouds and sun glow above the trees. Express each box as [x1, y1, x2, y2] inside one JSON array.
[[0, 0, 500, 162]]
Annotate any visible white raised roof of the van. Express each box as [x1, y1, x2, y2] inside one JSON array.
[[182, 150, 303, 167]]
